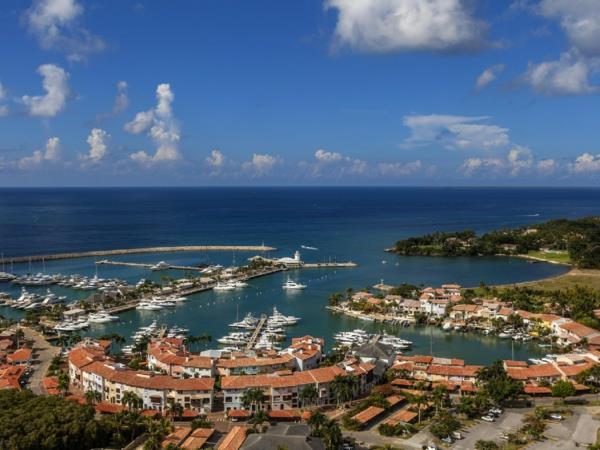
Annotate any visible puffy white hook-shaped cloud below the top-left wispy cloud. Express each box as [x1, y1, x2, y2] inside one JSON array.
[[22, 64, 69, 117]]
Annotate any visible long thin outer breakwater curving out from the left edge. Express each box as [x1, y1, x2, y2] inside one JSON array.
[[3, 245, 277, 264]]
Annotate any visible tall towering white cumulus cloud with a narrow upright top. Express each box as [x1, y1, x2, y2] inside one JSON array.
[[125, 83, 181, 163]]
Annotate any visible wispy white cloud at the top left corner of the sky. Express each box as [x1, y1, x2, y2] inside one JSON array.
[[24, 0, 106, 61]]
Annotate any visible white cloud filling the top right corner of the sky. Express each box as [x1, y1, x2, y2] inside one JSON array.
[[539, 0, 600, 56]]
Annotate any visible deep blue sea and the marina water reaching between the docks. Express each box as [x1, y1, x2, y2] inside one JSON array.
[[0, 188, 600, 363]]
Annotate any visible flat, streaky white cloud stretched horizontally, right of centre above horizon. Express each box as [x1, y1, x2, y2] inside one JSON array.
[[402, 114, 510, 149]]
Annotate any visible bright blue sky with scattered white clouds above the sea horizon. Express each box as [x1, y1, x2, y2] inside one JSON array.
[[0, 0, 600, 187]]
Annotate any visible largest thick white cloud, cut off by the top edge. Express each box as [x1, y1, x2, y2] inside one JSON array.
[[325, 0, 487, 52]]
